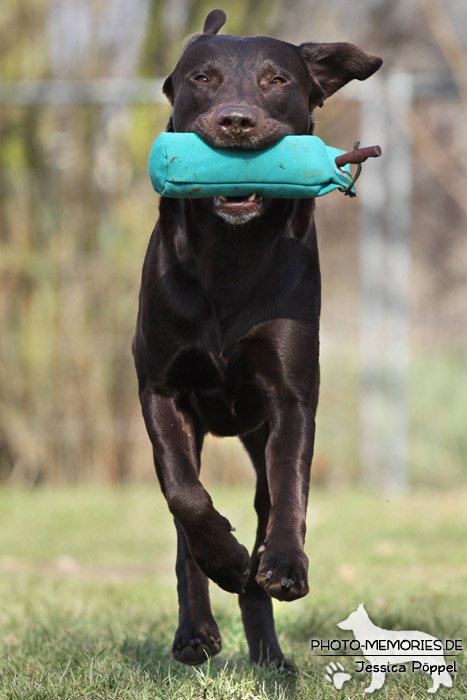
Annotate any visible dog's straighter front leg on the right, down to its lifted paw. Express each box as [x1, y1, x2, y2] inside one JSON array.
[[256, 395, 315, 600]]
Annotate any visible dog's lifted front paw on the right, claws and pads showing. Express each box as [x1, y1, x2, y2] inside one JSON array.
[[256, 545, 310, 601]]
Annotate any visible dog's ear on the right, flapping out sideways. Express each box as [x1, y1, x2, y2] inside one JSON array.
[[298, 42, 383, 106]]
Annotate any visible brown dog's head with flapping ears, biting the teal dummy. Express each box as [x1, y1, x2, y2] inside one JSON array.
[[164, 10, 382, 223]]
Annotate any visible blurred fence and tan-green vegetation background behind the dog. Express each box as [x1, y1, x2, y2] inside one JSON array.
[[0, 0, 467, 492]]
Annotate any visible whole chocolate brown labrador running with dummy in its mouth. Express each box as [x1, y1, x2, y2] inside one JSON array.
[[133, 10, 382, 665]]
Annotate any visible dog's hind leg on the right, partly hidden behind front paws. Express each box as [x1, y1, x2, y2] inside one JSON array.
[[238, 424, 289, 668]]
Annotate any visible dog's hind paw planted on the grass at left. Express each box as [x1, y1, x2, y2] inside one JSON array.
[[172, 622, 222, 666]]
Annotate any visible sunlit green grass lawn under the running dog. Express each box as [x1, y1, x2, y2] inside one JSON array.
[[0, 484, 467, 700]]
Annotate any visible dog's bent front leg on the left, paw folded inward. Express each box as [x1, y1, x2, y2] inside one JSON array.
[[140, 387, 249, 593]]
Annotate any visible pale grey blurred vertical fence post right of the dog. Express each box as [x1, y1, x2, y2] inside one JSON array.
[[359, 73, 412, 493]]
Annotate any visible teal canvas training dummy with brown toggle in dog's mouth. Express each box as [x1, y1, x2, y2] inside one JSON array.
[[149, 132, 381, 198]]
